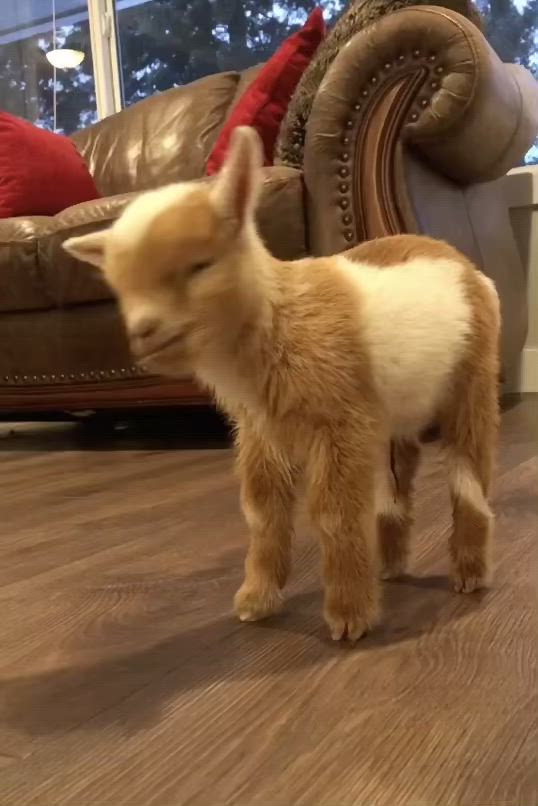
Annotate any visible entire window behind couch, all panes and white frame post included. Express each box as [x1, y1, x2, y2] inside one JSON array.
[[0, 0, 538, 164]]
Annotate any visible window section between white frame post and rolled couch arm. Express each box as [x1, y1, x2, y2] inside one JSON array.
[[116, 0, 346, 105]]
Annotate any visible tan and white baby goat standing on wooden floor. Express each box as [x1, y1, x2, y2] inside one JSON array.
[[65, 128, 500, 641]]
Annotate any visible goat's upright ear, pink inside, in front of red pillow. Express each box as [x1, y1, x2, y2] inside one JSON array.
[[212, 126, 263, 226]]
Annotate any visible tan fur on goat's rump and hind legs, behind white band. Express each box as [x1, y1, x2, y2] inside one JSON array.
[[347, 235, 500, 592]]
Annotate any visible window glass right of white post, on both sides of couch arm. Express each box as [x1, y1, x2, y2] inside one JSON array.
[[116, 0, 538, 164]]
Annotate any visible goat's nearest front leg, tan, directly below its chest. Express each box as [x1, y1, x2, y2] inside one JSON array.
[[308, 428, 379, 641]]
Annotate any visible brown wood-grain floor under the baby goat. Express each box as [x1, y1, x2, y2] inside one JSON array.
[[0, 401, 538, 806]]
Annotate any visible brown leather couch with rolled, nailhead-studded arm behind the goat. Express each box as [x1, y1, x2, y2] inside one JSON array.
[[0, 7, 538, 413]]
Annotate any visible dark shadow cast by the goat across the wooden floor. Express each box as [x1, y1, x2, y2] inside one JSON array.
[[0, 551, 483, 736]]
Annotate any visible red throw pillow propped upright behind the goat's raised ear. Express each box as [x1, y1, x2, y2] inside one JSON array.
[[206, 8, 325, 176]]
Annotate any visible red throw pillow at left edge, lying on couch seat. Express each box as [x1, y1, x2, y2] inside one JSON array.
[[0, 112, 100, 218]]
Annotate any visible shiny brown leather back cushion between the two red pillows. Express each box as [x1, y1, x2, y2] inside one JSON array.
[[73, 73, 239, 196]]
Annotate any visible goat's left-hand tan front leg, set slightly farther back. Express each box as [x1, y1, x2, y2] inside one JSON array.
[[234, 427, 296, 621]]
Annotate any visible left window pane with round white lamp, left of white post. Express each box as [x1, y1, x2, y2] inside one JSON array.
[[0, 0, 97, 134]]
